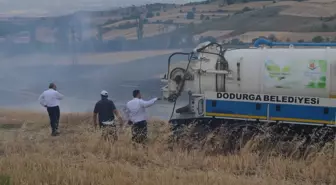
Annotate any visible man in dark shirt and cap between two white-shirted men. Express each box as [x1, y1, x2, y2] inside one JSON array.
[[93, 90, 122, 140]]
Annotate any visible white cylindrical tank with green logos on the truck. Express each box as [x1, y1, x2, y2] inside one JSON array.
[[220, 48, 336, 97]]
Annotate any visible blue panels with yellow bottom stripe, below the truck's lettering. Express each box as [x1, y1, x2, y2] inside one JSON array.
[[205, 100, 336, 124]]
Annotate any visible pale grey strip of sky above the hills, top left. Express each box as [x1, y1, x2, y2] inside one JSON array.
[[0, 0, 202, 16]]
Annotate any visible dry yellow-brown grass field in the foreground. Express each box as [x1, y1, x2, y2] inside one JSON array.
[[0, 110, 336, 185]]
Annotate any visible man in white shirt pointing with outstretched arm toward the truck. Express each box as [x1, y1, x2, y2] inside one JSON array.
[[125, 90, 159, 143]]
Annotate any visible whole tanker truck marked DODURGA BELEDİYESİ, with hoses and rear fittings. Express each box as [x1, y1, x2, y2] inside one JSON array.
[[161, 39, 336, 146]]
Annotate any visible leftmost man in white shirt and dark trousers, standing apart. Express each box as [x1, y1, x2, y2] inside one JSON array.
[[38, 83, 64, 136]]
